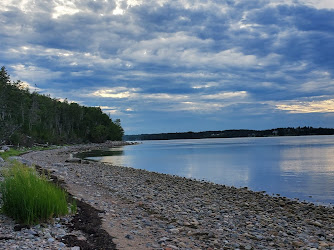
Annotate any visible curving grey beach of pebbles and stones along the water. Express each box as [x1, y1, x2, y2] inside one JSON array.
[[0, 144, 334, 250]]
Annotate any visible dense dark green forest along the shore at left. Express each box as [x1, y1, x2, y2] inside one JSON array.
[[0, 66, 124, 146]]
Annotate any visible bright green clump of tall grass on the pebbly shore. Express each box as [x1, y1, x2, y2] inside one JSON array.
[[0, 162, 73, 224]]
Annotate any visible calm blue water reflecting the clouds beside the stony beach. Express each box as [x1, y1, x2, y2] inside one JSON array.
[[83, 136, 334, 204]]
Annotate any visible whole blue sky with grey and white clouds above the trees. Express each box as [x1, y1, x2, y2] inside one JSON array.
[[0, 0, 334, 134]]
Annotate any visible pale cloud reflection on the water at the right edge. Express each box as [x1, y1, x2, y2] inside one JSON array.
[[280, 145, 334, 203]]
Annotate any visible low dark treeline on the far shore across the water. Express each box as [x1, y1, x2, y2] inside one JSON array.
[[123, 127, 334, 141]]
